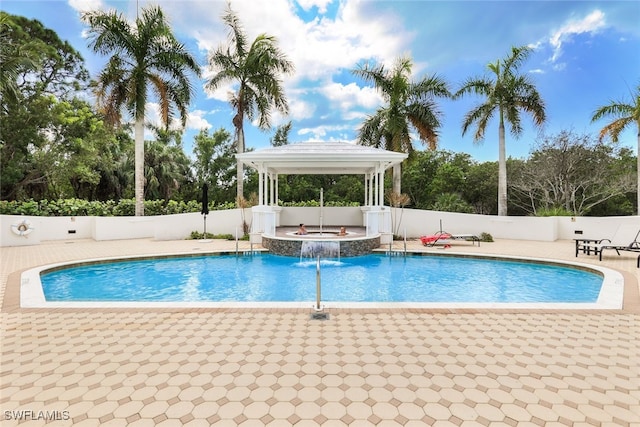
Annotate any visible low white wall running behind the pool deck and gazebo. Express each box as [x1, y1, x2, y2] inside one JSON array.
[[0, 207, 640, 246]]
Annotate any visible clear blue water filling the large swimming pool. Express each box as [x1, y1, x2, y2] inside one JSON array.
[[41, 254, 602, 303]]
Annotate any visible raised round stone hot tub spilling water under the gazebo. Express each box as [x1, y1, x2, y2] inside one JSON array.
[[262, 226, 380, 258]]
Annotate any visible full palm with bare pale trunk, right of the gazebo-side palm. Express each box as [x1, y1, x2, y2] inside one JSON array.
[[455, 46, 546, 215]]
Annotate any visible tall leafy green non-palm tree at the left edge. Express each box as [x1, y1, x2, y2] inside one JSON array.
[[0, 12, 89, 199]]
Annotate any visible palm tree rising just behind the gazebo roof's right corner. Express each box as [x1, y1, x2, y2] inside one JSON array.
[[352, 57, 451, 194]]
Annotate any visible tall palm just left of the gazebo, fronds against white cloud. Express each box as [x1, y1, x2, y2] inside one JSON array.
[[207, 7, 294, 199]]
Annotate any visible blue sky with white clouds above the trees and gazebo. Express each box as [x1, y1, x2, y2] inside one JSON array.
[[0, 0, 640, 161]]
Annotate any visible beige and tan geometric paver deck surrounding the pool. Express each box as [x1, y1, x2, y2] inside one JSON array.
[[0, 240, 640, 426]]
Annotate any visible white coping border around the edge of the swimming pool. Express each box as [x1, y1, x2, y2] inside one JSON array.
[[16, 250, 629, 311]]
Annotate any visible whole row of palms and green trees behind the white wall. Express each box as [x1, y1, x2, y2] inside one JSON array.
[[0, 7, 640, 215]]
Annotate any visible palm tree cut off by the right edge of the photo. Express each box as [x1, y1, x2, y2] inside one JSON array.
[[591, 84, 640, 215]]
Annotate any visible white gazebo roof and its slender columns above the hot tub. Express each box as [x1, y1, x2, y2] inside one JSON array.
[[236, 142, 407, 206]]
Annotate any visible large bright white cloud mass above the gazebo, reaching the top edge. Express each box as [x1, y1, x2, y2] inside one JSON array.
[[163, 0, 422, 137]]
